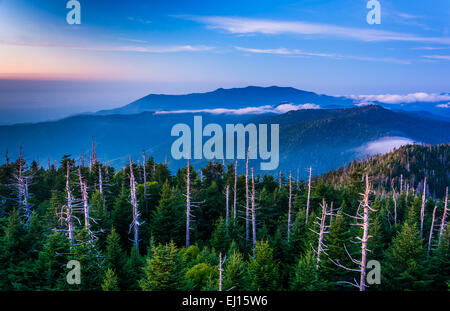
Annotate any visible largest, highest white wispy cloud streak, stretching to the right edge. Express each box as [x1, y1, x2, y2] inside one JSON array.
[[184, 16, 450, 45]]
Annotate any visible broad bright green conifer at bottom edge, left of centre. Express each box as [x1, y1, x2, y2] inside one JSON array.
[[139, 242, 184, 291]]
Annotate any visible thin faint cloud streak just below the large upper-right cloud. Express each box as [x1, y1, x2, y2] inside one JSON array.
[[234, 46, 411, 65]]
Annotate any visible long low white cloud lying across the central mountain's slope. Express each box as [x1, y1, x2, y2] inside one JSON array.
[[155, 103, 320, 115]]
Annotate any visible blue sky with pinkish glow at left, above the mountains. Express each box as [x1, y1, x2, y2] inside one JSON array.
[[0, 0, 450, 124]]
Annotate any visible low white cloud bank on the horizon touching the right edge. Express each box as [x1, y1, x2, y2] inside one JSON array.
[[347, 92, 450, 105]]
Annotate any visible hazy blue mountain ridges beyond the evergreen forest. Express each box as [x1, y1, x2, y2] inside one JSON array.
[[0, 87, 450, 178]]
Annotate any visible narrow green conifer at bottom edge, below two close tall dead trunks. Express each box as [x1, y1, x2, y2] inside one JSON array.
[[248, 241, 279, 290]]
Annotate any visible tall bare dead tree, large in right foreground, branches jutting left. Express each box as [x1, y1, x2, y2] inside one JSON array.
[[330, 174, 375, 291]]
